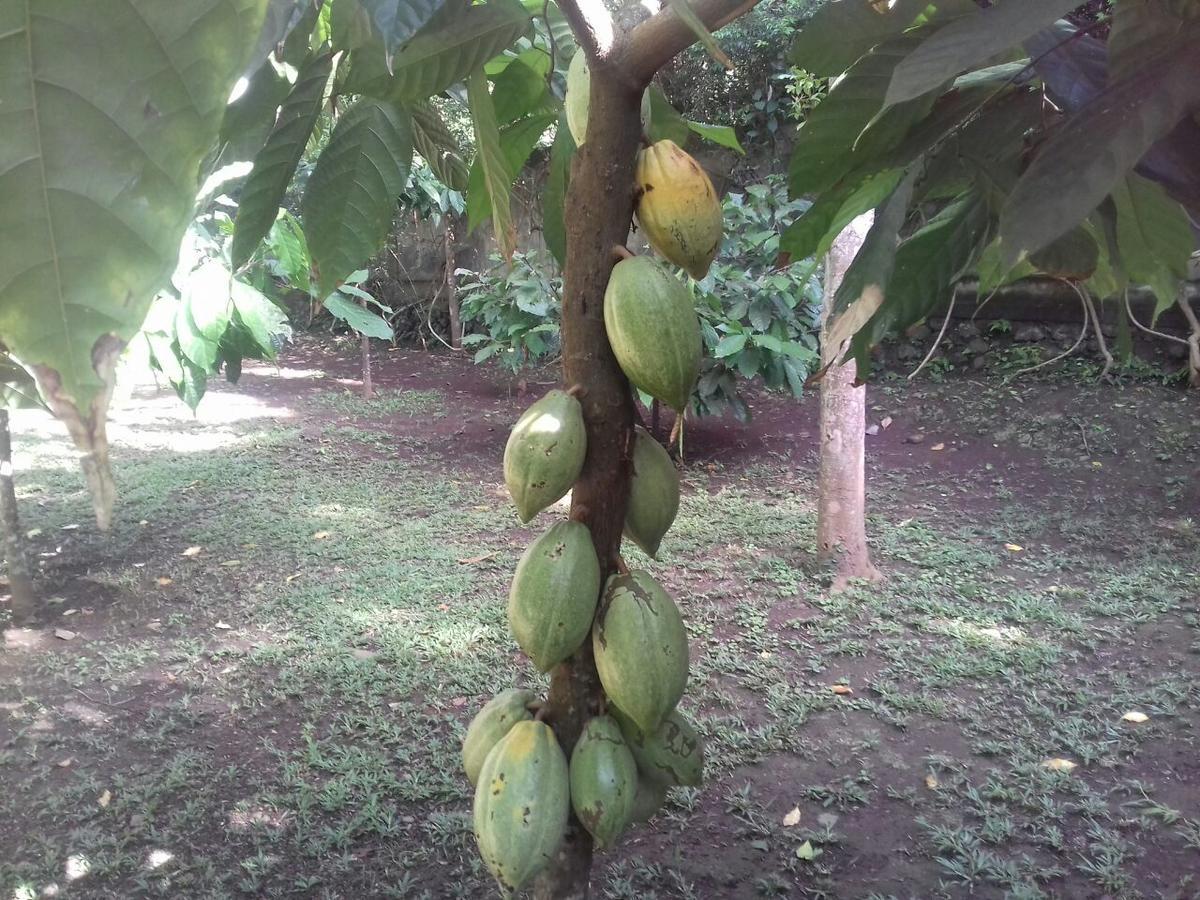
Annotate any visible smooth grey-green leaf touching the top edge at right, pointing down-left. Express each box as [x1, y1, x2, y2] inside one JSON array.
[[884, 0, 1079, 107]]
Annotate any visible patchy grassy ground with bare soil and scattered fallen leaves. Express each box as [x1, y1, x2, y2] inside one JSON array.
[[0, 348, 1200, 900]]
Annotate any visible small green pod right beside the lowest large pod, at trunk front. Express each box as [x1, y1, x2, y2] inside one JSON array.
[[571, 715, 637, 847]]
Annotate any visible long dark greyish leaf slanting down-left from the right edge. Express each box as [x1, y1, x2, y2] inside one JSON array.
[[1000, 31, 1200, 262]]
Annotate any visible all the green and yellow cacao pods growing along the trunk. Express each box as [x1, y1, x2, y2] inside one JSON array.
[[462, 54, 721, 892]]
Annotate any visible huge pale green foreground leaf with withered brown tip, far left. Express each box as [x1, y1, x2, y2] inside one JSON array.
[[0, 0, 265, 529]]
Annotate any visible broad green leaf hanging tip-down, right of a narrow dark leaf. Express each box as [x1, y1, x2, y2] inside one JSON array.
[[300, 98, 413, 296]]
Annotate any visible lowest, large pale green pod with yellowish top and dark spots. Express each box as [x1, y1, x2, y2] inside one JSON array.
[[474, 721, 571, 892]]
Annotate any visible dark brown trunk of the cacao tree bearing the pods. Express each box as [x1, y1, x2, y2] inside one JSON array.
[[534, 58, 642, 900]]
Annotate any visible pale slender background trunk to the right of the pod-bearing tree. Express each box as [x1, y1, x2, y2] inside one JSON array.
[[817, 212, 882, 590]]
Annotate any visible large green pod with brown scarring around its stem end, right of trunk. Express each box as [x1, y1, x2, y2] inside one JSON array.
[[592, 571, 688, 733]]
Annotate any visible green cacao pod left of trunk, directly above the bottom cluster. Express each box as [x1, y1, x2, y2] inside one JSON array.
[[509, 522, 600, 672]]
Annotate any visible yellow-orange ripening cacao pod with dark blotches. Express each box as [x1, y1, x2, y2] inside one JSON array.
[[636, 140, 724, 281]]
